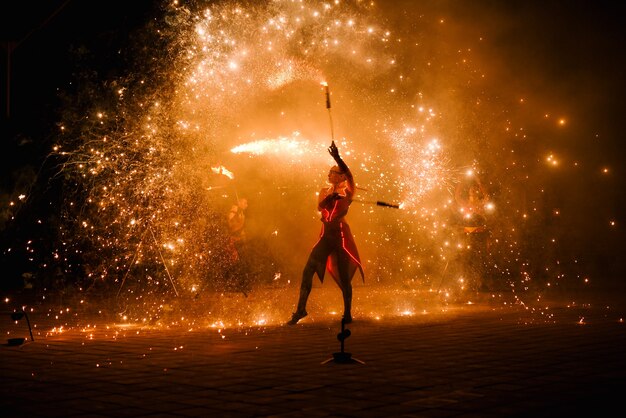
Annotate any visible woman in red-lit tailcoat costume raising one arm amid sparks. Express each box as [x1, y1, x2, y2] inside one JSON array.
[[287, 141, 365, 325]]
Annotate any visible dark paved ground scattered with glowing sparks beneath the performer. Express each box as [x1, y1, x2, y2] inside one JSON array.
[[0, 288, 626, 417]]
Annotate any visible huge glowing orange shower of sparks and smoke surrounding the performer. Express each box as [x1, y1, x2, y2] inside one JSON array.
[[22, 0, 584, 320]]
